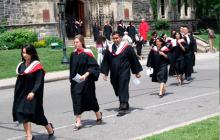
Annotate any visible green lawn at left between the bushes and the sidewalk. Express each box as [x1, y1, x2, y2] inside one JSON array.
[[0, 48, 97, 79]]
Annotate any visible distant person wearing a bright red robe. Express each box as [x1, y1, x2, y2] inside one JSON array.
[[139, 19, 150, 43]]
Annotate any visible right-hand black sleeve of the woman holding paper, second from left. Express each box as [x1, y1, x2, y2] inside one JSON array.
[[88, 56, 100, 81]]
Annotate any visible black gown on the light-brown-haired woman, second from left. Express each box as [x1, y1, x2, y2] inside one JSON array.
[[70, 49, 100, 115]]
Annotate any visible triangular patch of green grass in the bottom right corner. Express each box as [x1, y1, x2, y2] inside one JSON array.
[[143, 116, 219, 140]]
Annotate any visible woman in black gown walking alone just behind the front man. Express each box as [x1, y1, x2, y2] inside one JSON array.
[[147, 38, 170, 97]]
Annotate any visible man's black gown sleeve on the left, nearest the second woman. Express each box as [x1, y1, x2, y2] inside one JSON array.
[[101, 48, 110, 75]]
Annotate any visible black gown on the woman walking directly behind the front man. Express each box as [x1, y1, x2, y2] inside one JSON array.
[[147, 46, 171, 83]]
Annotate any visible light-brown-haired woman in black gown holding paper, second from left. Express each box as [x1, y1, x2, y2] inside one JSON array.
[[70, 35, 102, 130]]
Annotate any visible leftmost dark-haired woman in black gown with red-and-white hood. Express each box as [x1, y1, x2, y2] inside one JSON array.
[[12, 45, 54, 140]]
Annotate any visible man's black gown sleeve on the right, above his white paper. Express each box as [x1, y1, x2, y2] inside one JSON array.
[[128, 46, 143, 74]]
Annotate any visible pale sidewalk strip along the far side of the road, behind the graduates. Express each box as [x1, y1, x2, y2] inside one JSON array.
[[0, 52, 219, 90]]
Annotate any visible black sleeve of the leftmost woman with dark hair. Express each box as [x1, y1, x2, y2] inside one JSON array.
[[32, 70, 44, 93]]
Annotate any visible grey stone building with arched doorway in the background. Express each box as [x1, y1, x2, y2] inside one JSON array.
[[0, 0, 195, 36]]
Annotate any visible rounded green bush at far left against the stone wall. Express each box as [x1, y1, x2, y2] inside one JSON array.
[[0, 29, 37, 50]]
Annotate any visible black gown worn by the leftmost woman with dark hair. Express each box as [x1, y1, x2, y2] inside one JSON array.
[[13, 63, 48, 126]]
